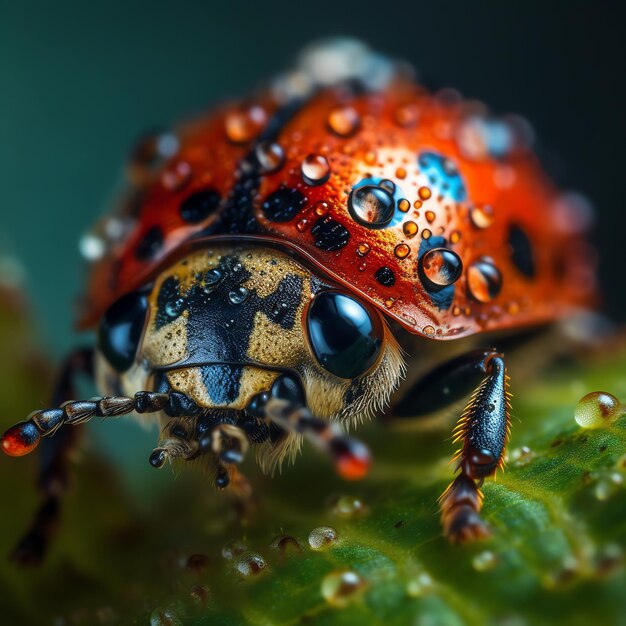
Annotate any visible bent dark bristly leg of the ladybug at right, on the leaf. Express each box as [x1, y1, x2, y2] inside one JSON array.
[[394, 350, 511, 542]]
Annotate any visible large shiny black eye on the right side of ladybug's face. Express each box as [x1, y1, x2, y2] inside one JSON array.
[[307, 291, 383, 378]]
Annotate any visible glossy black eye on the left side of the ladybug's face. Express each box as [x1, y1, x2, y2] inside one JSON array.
[[98, 291, 148, 373]]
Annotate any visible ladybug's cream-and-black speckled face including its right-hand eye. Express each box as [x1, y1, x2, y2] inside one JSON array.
[[125, 241, 403, 417]]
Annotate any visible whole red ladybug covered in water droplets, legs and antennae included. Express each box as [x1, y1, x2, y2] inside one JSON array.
[[2, 36, 595, 560]]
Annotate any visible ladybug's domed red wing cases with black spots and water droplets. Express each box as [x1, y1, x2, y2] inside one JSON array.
[[79, 80, 595, 339]]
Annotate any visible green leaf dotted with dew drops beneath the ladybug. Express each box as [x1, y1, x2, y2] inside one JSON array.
[[0, 280, 626, 626]]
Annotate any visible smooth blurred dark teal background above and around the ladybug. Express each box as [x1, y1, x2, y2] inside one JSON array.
[[0, 0, 626, 355]]
